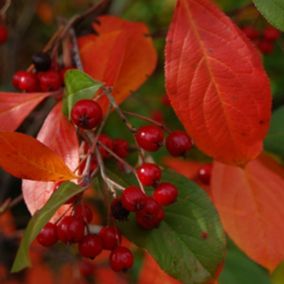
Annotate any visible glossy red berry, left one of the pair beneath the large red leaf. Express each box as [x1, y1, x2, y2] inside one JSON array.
[[135, 125, 164, 152]]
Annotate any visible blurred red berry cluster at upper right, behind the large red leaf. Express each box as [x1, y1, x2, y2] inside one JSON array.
[[242, 26, 281, 54]]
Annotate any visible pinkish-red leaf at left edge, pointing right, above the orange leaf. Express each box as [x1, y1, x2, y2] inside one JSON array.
[[0, 93, 52, 131]]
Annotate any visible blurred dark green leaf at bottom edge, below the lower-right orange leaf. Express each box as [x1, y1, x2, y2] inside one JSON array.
[[218, 243, 270, 284]]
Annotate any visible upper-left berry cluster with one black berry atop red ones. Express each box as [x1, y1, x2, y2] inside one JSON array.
[[12, 52, 70, 92]]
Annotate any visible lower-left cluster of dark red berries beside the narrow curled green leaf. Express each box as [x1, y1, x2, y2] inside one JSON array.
[[37, 203, 133, 271]]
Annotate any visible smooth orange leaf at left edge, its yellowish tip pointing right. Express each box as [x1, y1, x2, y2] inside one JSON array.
[[0, 132, 76, 181]]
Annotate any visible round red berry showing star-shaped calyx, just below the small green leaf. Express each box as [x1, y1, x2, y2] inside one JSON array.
[[71, 100, 103, 129]]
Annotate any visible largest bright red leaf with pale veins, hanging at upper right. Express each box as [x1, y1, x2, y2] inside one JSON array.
[[165, 0, 271, 165]]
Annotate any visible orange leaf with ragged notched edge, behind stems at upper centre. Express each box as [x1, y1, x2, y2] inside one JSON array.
[[78, 16, 157, 109]]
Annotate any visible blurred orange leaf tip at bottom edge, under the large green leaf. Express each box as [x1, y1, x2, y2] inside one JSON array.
[[138, 254, 181, 284]]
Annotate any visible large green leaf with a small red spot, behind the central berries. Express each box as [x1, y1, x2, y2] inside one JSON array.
[[108, 170, 225, 284]]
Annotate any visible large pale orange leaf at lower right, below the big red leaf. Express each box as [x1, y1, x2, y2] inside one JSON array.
[[211, 156, 284, 271]]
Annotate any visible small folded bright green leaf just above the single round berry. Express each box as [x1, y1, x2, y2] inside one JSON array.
[[63, 70, 103, 118]]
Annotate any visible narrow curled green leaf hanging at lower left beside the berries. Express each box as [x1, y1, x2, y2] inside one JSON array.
[[12, 182, 85, 272]]
